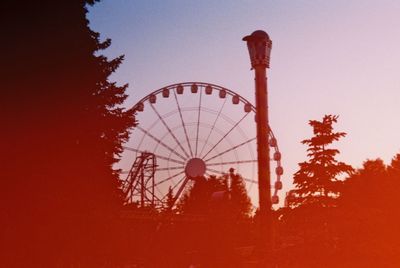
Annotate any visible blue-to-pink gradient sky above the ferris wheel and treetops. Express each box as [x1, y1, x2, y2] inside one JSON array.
[[88, 0, 400, 199]]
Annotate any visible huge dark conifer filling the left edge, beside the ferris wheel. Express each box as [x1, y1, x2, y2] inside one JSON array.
[[0, 0, 134, 267]]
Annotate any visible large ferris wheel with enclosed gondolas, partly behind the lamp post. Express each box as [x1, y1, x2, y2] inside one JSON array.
[[119, 82, 283, 207]]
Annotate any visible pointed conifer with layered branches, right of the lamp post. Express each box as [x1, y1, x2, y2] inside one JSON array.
[[288, 115, 353, 207]]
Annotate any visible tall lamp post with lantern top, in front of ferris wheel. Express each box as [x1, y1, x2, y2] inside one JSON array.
[[243, 30, 272, 252]]
